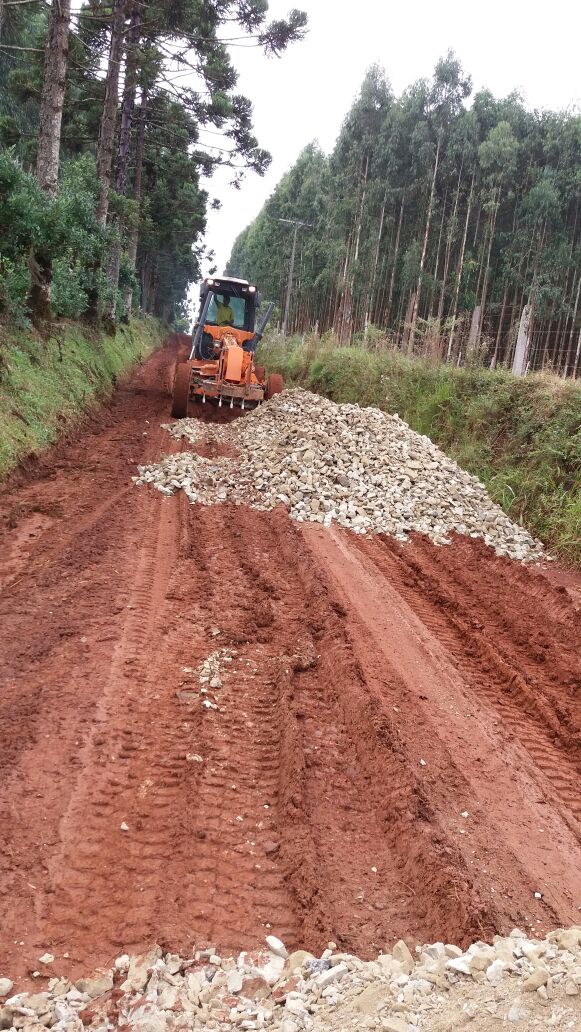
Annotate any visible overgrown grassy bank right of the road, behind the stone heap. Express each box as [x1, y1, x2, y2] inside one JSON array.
[[259, 337, 581, 565]]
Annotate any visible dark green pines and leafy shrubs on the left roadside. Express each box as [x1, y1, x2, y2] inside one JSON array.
[[0, 0, 306, 329]]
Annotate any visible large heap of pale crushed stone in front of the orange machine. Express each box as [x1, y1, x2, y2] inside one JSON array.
[[133, 390, 543, 561]]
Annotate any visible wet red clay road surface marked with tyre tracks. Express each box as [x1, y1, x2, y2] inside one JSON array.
[[0, 342, 581, 979]]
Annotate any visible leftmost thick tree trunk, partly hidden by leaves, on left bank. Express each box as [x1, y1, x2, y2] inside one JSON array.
[[29, 0, 70, 328]]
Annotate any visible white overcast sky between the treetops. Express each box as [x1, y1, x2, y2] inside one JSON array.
[[204, 0, 581, 282]]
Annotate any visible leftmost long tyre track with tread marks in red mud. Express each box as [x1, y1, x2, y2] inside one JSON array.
[[42, 487, 186, 953]]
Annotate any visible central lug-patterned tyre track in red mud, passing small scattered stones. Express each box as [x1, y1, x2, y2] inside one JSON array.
[[172, 506, 297, 949]]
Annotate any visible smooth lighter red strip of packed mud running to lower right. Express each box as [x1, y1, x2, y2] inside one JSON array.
[[302, 526, 581, 931]]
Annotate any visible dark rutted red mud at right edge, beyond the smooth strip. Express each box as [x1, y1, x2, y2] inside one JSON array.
[[358, 539, 581, 829]]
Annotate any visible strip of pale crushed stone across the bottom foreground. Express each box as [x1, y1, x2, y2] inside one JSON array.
[[0, 927, 581, 1032]]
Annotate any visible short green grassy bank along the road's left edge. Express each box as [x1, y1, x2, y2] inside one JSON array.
[[0, 319, 166, 479]]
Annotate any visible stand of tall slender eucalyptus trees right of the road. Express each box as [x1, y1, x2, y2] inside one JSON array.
[[228, 52, 581, 377]]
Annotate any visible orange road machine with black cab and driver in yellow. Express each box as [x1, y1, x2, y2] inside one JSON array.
[[171, 277, 283, 419]]
